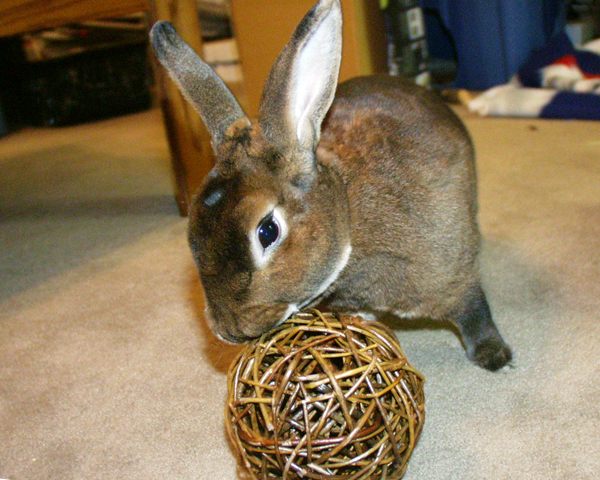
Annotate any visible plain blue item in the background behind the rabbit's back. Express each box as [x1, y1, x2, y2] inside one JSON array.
[[421, 0, 567, 90]]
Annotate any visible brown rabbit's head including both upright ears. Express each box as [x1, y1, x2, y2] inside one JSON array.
[[151, 0, 351, 342]]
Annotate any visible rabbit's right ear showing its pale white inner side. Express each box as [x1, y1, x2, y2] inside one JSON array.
[[259, 0, 342, 154]]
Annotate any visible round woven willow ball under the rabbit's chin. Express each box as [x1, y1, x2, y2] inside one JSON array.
[[225, 310, 425, 480]]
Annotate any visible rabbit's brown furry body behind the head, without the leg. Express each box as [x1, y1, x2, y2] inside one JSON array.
[[317, 76, 479, 317]]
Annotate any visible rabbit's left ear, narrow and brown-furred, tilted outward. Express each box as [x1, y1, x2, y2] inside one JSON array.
[[150, 22, 249, 145]]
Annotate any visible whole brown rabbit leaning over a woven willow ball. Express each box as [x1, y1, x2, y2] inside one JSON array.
[[151, 0, 511, 370]]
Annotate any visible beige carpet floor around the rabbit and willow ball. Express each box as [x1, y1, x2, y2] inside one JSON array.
[[0, 107, 600, 480]]
